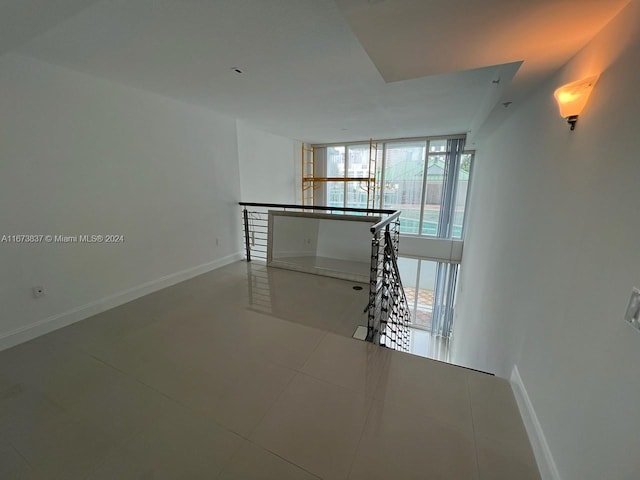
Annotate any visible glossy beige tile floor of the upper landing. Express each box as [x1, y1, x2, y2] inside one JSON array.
[[0, 262, 539, 480]]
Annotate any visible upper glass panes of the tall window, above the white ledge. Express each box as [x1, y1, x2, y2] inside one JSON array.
[[316, 137, 473, 239]]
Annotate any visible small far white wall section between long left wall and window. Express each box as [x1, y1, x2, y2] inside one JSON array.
[[237, 120, 302, 203]]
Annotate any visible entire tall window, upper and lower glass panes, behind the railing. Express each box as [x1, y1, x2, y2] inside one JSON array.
[[315, 136, 473, 354]]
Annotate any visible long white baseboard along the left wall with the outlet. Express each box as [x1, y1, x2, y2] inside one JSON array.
[[0, 252, 243, 351]]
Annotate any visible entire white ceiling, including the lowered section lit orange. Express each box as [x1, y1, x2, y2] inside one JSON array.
[[0, 0, 629, 142]]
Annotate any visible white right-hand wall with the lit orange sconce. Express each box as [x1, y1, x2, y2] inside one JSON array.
[[453, 0, 640, 480]]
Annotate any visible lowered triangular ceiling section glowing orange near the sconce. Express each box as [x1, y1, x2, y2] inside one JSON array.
[[337, 0, 629, 82]]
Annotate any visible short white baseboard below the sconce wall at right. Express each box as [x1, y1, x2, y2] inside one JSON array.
[[511, 365, 562, 480]]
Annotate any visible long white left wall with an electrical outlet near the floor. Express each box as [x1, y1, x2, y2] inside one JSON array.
[[0, 55, 242, 347]]
